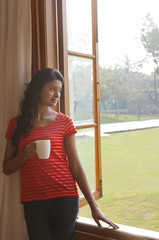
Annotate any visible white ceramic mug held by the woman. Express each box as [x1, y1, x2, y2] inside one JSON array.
[[35, 140, 50, 159]]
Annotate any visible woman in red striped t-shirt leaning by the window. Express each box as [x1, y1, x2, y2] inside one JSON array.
[[3, 68, 118, 240]]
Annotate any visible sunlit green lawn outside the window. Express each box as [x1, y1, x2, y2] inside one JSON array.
[[79, 128, 159, 231]]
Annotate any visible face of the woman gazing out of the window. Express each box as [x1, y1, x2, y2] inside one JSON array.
[[39, 80, 62, 107]]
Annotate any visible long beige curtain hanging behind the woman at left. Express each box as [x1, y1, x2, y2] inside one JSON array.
[[0, 0, 31, 240]]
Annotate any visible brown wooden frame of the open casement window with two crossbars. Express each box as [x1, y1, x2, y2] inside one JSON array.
[[57, 0, 102, 206]]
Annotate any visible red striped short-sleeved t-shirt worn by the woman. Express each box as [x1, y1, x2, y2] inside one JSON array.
[[6, 112, 78, 202]]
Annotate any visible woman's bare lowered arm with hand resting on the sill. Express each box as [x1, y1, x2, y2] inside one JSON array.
[[65, 134, 118, 229]]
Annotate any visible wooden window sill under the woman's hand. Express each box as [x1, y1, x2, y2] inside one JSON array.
[[72, 217, 159, 240]]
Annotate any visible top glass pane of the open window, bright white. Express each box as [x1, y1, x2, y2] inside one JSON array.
[[66, 0, 92, 54]]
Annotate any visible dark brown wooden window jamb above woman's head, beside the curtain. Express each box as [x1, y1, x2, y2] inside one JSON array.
[[31, 0, 58, 75]]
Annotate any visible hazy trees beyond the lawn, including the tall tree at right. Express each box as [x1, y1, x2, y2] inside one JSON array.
[[99, 13, 159, 120]]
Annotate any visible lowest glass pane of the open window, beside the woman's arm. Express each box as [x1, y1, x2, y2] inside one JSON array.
[[76, 128, 96, 195]]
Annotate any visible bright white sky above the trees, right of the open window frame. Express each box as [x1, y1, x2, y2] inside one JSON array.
[[98, 0, 159, 74]]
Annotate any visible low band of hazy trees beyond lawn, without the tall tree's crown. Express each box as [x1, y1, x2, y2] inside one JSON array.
[[99, 66, 159, 120]]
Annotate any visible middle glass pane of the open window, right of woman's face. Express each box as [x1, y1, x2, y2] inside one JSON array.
[[68, 56, 94, 123]]
